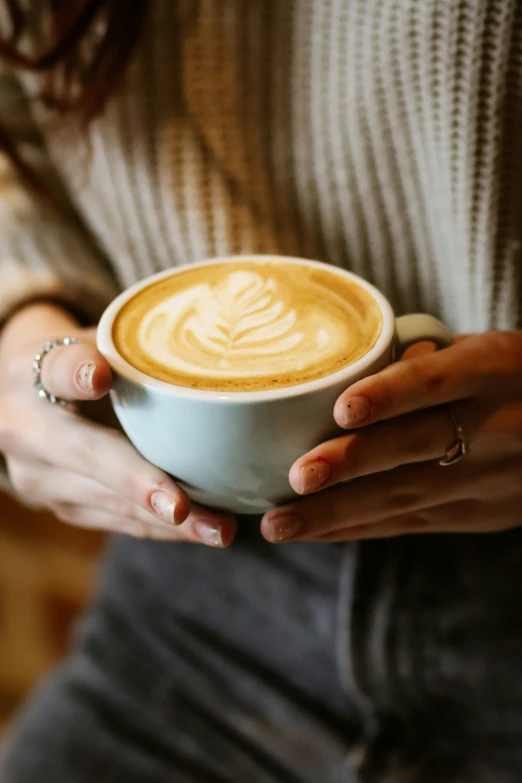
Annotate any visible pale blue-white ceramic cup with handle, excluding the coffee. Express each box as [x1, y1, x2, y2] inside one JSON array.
[[98, 256, 453, 514]]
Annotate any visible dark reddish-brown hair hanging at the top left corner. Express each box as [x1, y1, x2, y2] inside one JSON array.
[[0, 0, 147, 190]]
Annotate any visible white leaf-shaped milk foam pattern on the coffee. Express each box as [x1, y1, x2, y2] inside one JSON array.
[[139, 271, 354, 378]]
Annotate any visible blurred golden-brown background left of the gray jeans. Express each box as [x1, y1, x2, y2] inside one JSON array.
[[0, 493, 104, 729]]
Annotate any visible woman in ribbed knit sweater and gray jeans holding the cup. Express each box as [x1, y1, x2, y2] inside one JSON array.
[[0, 0, 522, 783]]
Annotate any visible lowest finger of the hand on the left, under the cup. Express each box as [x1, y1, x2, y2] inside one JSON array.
[[53, 503, 235, 548]]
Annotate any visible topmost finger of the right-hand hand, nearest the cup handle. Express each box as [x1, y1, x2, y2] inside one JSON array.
[[334, 332, 522, 429]]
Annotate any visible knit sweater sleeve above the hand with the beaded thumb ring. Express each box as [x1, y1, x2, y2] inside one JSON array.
[[0, 68, 117, 324]]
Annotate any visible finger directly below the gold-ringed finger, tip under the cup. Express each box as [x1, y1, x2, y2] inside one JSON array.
[[261, 460, 464, 543]]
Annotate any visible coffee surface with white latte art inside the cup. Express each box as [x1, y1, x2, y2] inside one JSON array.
[[112, 259, 382, 392]]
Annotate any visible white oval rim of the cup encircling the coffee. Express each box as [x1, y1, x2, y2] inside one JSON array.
[[97, 253, 395, 403]]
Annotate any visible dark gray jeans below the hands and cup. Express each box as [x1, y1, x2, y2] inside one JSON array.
[[0, 520, 522, 783]]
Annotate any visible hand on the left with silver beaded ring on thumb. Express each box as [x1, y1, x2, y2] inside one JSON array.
[[0, 305, 235, 546]]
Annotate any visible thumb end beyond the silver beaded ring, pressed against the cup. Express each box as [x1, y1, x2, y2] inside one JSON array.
[[41, 343, 112, 400]]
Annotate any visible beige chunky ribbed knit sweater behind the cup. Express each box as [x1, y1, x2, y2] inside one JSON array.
[[0, 0, 522, 331]]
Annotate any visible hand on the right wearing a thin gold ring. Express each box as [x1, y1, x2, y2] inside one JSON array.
[[261, 332, 522, 543]]
